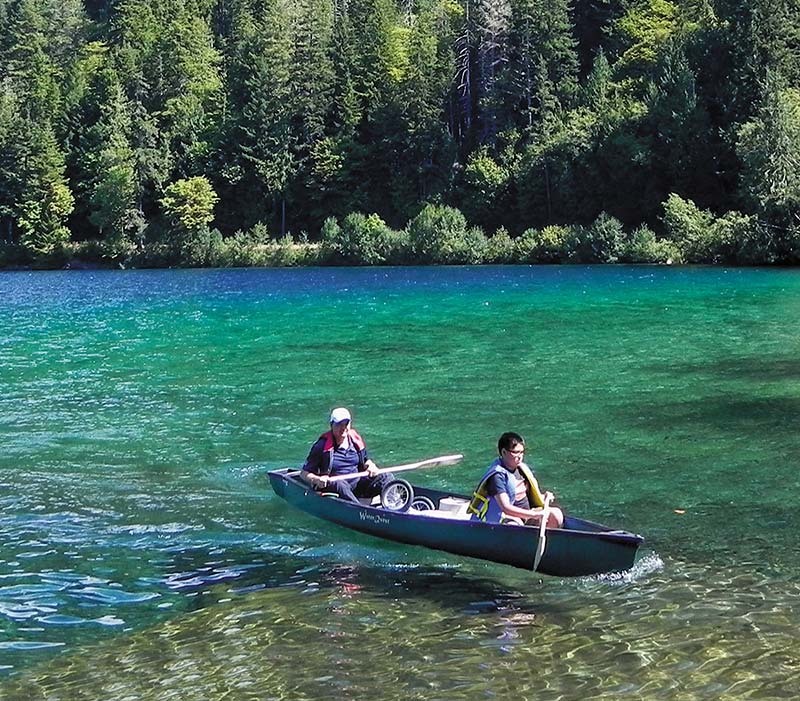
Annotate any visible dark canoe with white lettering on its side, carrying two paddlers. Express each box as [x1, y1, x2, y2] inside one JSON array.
[[269, 468, 644, 577]]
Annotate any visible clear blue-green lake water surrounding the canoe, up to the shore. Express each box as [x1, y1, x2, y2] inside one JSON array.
[[0, 266, 800, 701]]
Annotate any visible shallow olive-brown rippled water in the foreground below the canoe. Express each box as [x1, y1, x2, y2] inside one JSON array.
[[2, 563, 800, 701]]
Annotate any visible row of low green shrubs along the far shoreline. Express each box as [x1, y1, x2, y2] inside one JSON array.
[[0, 194, 800, 269]]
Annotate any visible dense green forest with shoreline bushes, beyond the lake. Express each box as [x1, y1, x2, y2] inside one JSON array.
[[0, 0, 800, 268]]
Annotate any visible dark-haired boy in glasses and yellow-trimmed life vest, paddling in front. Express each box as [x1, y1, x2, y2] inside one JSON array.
[[468, 431, 564, 528]]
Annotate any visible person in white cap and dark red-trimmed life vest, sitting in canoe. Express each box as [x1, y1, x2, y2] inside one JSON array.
[[300, 407, 392, 502]]
